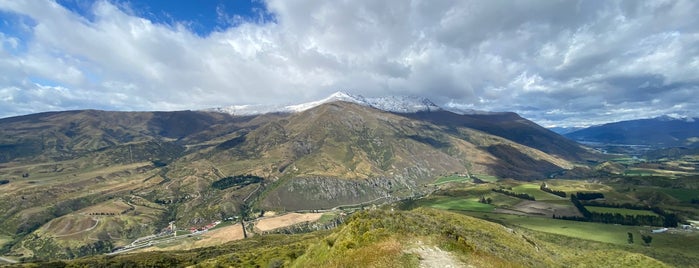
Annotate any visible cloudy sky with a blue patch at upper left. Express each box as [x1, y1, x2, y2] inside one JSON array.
[[0, 0, 699, 127]]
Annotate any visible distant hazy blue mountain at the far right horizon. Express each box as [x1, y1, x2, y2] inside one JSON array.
[[565, 116, 699, 148]]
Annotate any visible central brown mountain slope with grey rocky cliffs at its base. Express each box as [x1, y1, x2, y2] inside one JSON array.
[[190, 102, 572, 209]]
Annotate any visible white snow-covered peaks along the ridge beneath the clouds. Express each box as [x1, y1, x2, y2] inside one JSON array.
[[209, 91, 442, 115]]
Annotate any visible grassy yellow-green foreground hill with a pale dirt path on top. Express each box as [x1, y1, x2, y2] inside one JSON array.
[[16, 209, 667, 267]]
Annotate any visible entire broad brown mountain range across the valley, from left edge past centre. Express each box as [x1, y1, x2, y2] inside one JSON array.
[[0, 97, 590, 259]]
